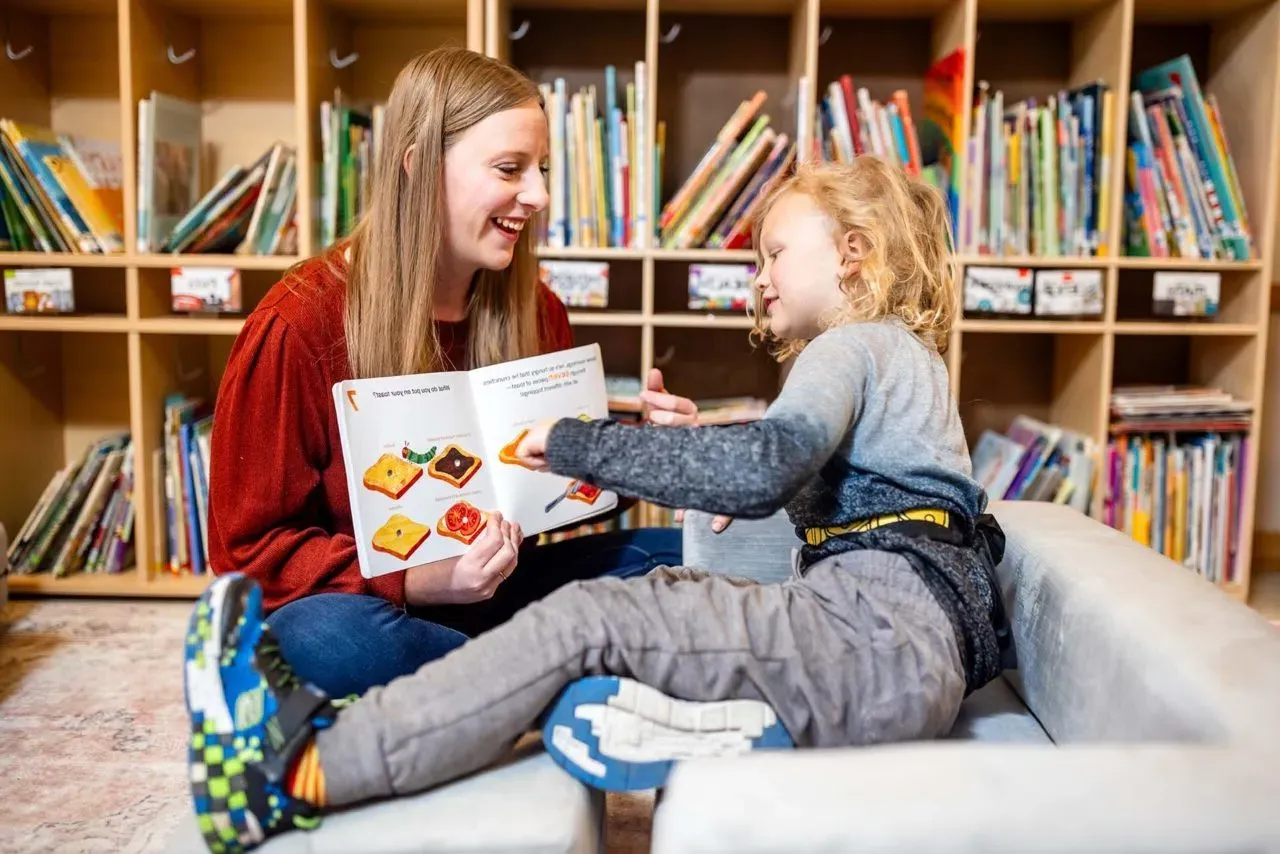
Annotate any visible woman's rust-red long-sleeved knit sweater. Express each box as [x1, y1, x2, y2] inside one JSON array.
[[209, 248, 573, 612]]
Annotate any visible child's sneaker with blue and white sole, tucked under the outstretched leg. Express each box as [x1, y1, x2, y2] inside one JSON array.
[[543, 676, 794, 791]]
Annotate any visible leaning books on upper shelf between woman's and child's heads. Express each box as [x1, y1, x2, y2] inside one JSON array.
[[658, 90, 796, 250]]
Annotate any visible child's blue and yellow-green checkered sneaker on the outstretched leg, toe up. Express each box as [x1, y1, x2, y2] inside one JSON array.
[[183, 575, 335, 853]]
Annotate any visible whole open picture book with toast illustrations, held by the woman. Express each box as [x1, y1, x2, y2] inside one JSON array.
[[333, 344, 618, 577]]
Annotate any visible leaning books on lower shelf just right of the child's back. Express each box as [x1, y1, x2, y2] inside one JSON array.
[[972, 415, 1098, 513]]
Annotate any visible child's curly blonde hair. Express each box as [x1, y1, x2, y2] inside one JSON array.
[[751, 155, 960, 361]]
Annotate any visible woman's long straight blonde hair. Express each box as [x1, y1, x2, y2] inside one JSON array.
[[332, 47, 541, 379]]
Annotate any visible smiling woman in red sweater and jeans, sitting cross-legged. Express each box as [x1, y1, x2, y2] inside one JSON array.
[[209, 49, 694, 697]]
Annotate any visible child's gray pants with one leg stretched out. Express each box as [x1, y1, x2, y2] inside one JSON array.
[[317, 552, 965, 805]]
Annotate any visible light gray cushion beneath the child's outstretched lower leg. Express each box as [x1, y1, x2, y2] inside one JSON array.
[[168, 748, 604, 854]]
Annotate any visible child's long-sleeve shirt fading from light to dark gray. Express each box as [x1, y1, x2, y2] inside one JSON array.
[[547, 320, 998, 682]]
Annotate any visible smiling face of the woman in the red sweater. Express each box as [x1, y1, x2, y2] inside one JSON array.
[[444, 101, 548, 275]]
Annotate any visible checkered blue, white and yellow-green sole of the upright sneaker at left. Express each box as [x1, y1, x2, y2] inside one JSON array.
[[183, 576, 265, 853]]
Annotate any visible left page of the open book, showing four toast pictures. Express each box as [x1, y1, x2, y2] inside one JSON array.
[[334, 373, 497, 577]]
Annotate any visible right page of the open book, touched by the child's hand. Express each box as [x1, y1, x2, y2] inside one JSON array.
[[471, 344, 618, 536]]
